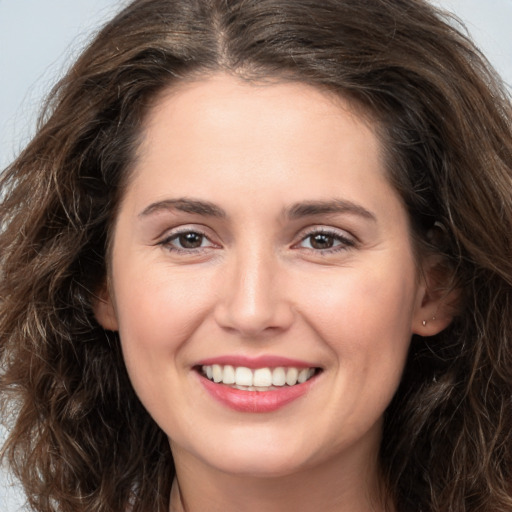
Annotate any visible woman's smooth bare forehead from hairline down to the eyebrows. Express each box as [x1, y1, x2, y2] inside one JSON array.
[[112, 75, 408, 260]]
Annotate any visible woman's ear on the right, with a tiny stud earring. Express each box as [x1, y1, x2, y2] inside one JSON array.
[[412, 255, 460, 336]]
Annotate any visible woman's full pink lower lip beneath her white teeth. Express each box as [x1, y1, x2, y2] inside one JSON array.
[[199, 375, 316, 413]]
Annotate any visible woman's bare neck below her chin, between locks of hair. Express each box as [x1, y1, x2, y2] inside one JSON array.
[[170, 444, 393, 512]]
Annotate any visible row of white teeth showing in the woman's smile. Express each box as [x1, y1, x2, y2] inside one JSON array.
[[199, 364, 320, 391]]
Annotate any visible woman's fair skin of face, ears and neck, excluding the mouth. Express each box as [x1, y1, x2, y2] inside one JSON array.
[[96, 75, 450, 512]]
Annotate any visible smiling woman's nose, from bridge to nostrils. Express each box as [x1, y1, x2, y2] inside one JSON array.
[[215, 250, 294, 338]]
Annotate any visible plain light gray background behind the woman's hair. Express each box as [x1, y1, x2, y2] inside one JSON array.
[[0, 0, 512, 512]]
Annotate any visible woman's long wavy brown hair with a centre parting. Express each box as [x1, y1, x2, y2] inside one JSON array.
[[0, 0, 512, 512]]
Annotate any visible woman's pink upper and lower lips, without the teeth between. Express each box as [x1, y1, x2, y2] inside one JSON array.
[[197, 356, 316, 413]]
